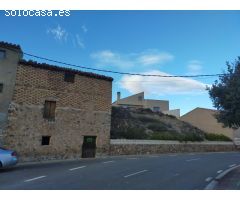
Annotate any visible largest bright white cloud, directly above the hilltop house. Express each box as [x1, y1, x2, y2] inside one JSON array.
[[119, 70, 207, 96]]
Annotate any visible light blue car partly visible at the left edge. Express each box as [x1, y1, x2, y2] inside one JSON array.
[[0, 147, 18, 168]]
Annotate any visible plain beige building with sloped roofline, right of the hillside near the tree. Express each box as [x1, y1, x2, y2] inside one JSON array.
[[180, 108, 234, 138]]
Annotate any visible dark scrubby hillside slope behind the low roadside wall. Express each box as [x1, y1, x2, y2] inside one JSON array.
[[111, 107, 231, 141]]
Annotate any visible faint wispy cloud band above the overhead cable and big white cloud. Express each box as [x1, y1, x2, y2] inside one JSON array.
[[91, 50, 174, 68]]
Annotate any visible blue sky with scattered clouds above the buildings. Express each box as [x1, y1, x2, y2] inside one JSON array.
[[0, 11, 240, 114]]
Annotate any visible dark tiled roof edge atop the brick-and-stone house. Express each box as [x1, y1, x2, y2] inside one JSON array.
[[19, 60, 113, 81]]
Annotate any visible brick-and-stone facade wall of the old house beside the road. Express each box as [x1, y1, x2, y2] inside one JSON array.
[[4, 65, 112, 161]]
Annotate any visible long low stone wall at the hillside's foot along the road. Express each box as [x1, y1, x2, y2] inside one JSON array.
[[110, 140, 237, 156]]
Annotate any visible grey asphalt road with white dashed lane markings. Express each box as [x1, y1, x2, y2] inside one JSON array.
[[0, 152, 240, 190]]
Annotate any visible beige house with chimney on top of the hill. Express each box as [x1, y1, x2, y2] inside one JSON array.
[[112, 92, 180, 118]]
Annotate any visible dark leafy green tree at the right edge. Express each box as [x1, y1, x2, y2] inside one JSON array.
[[207, 57, 240, 128]]
